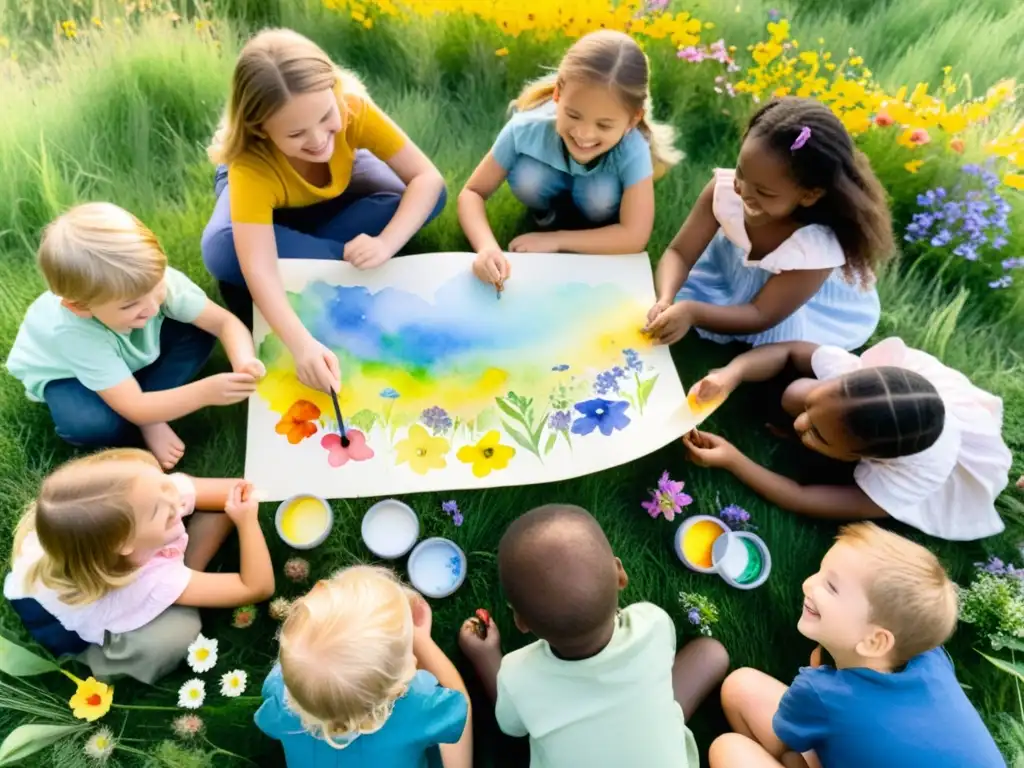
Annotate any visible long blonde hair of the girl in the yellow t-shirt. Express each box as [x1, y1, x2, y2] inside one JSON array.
[[207, 30, 370, 164]]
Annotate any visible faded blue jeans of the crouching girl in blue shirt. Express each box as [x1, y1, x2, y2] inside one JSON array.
[[508, 155, 623, 226]]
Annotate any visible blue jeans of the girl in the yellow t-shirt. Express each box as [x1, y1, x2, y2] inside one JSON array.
[[202, 150, 447, 286]]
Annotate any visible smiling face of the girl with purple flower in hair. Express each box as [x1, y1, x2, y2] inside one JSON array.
[[734, 132, 823, 226]]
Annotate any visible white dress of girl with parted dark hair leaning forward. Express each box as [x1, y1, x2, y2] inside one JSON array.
[[811, 338, 1013, 542]]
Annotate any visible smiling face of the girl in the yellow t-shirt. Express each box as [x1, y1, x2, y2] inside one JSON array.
[[262, 88, 342, 163]]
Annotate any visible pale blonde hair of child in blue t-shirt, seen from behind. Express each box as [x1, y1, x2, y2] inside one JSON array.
[[280, 565, 416, 749]]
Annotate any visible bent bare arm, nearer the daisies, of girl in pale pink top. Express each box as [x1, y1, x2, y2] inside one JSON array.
[[175, 480, 274, 608]]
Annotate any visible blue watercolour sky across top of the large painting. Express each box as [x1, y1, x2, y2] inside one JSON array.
[[296, 273, 642, 373]]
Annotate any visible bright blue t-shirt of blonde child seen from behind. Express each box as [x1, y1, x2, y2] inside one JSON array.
[[255, 665, 467, 768]]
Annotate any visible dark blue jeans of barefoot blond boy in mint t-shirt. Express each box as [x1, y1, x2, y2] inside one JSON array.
[[43, 317, 216, 446]]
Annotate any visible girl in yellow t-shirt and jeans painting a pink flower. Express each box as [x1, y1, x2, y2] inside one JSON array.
[[203, 30, 445, 391]]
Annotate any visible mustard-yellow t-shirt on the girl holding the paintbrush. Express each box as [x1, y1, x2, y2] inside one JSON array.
[[227, 88, 408, 224]]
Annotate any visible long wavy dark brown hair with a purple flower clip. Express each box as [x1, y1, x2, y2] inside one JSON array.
[[743, 96, 896, 286]]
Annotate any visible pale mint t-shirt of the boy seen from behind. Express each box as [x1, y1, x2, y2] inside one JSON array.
[[495, 603, 699, 768]]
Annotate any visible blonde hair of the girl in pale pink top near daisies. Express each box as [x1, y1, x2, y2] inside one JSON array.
[[13, 449, 160, 605]]
